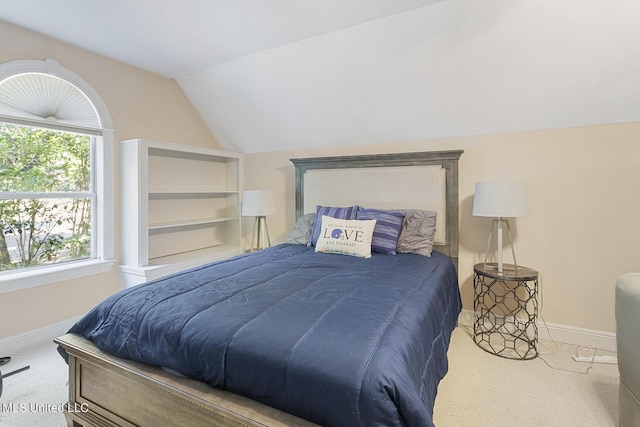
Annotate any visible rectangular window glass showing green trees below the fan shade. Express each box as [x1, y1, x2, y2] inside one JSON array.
[[0, 122, 96, 272]]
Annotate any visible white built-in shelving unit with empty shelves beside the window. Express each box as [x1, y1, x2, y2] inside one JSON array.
[[120, 139, 243, 286]]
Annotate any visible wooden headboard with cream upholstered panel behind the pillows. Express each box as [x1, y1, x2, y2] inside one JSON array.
[[291, 150, 463, 267]]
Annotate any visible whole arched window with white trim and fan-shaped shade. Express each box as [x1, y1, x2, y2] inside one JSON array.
[[0, 59, 114, 293]]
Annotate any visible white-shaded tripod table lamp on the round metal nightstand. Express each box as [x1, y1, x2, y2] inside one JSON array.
[[473, 182, 529, 274]]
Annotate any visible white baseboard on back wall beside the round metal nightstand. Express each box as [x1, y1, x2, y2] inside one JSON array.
[[458, 310, 616, 351]]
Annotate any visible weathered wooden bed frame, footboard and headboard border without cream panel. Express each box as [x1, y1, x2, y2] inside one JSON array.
[[55, 150, 462, 427]]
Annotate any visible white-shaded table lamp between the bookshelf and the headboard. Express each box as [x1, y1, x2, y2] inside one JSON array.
[[242, 190, 278, 252]]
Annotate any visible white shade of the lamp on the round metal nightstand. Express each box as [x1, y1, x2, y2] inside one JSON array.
[[473, 182, 529, 218]]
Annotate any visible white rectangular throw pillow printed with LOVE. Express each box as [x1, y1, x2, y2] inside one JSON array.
[[316, 215, 376, 258]]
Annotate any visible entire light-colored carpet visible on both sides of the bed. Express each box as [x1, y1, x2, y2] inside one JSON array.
[[0, 327, 618, 427]]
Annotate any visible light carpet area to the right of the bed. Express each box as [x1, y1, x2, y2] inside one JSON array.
[[434, 327, 619, 427]]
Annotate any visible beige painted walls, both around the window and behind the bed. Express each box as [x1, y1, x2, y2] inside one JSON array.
[[0, 21, 640, 339]]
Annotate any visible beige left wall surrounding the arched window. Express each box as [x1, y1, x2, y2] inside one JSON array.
[[0, 21, 219, 339]]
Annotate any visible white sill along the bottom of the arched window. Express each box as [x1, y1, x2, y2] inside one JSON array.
[[0, 259, 115, 294]]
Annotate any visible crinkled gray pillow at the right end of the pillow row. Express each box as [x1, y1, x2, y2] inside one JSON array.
[[396, 209, 437, 256]]
